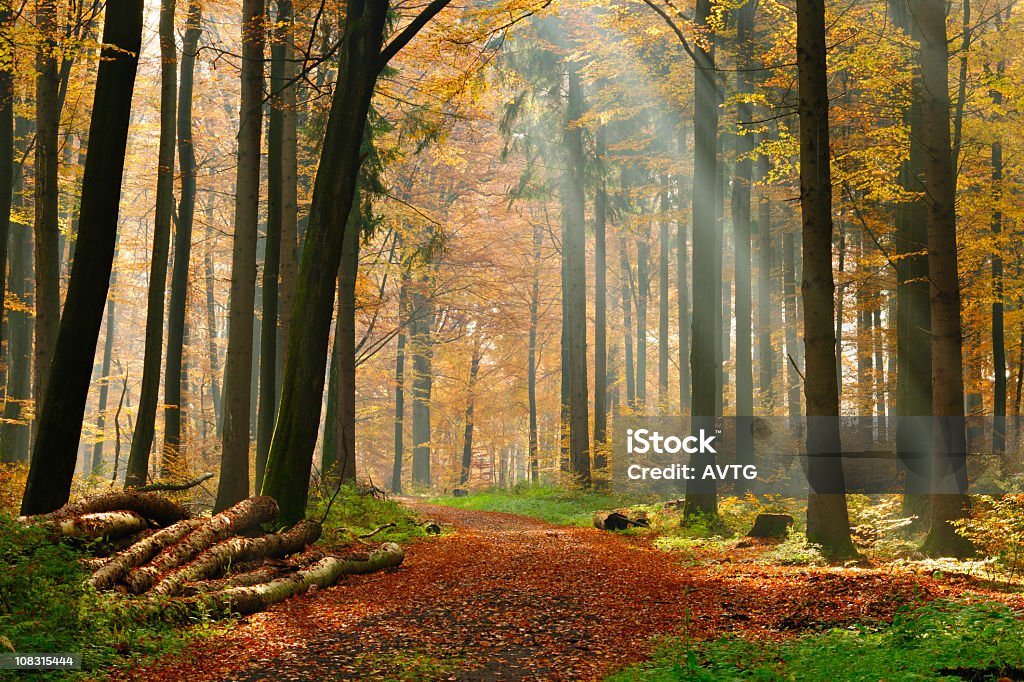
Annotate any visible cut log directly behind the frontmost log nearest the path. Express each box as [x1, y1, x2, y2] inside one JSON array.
[[153, 519, 322, 596]]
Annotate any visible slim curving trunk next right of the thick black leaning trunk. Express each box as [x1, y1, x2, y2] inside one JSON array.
[[125, 0, 179, 483]]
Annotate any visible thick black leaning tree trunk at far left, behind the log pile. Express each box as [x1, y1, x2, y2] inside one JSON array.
[[22, 0, 143, 515]]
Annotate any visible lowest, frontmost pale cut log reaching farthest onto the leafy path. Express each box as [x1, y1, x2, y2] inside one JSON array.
[[182, 543, 406, 615]]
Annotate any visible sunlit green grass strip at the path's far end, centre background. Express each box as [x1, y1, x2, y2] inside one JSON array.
[[429, 485, 639, 526]]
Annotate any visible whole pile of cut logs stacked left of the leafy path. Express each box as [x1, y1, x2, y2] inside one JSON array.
[[22, 491, 404, 614]]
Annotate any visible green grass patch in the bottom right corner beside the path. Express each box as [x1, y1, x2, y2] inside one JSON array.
[[606, 601, 1024, 682]]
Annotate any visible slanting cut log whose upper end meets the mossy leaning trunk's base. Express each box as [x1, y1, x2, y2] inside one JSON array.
[[124, 497, 278, 594]]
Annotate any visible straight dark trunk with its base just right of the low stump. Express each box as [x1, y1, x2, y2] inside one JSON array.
[[797, 0, 856, 556]]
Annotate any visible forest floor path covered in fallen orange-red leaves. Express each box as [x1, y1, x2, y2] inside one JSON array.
[[105, 503, 1024, 680]]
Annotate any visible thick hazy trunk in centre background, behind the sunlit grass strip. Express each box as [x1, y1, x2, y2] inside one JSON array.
[[562, 63, 591, 487]]
